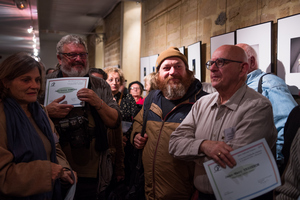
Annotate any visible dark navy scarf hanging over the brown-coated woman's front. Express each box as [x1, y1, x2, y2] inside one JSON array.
[[3, 98, 61, 200]]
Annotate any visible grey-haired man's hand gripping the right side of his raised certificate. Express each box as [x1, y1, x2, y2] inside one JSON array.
[[77, 88, 103, 109]]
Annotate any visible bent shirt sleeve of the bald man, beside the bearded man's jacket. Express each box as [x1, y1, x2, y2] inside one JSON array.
[[169, 102, 204, 161]]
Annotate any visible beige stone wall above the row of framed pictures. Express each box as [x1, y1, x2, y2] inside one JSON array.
[[141, 0, 300, 82]]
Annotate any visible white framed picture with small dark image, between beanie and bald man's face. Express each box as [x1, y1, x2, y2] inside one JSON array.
[[188, 41, 201, 81]]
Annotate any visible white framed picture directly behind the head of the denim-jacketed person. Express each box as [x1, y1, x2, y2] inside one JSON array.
[[236, 21, 274, 72]]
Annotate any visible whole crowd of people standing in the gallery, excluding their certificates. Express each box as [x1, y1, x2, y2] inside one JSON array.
[[0, 35, 300, 200]]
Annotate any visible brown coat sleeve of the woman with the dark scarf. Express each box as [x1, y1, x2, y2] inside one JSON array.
[[0, 116, 52, 197]]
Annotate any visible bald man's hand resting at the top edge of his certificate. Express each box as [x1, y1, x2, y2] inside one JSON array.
[[199, 140, 236, 168]]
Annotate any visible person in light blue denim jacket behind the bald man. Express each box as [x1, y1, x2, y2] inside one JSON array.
[[236, 43, 297, 174]]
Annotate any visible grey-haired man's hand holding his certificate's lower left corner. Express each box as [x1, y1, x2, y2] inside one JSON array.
[[46, 95, 74, 118]]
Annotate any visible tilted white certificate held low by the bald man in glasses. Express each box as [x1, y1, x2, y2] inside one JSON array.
[[204, 138, 281, 200]]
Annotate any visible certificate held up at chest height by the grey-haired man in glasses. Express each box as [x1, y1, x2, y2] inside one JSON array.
[[44, 77, 89, 107]]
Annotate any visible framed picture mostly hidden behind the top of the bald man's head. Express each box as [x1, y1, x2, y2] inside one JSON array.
[[210, 31, 236, 57]]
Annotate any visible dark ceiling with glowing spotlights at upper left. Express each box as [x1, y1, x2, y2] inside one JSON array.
[[0, 0, 141, 55]]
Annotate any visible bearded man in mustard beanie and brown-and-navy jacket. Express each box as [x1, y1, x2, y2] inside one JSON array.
[[131, 47, 207, 199]]
